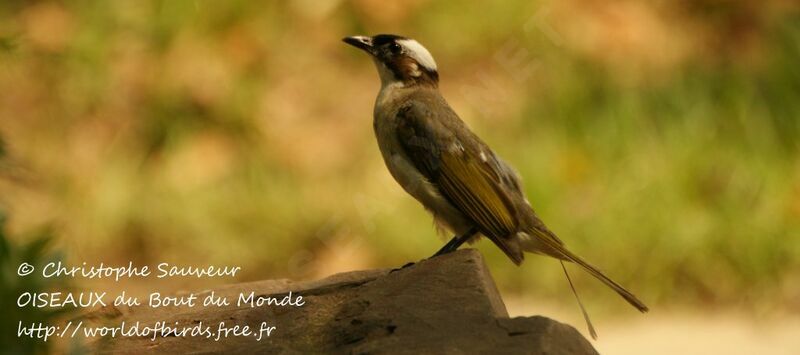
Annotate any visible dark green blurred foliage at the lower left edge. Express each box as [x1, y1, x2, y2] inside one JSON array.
[[0, 211, 70, 354]]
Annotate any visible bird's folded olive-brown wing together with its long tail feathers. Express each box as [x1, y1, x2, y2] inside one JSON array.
[[395, 97, 648, 312]]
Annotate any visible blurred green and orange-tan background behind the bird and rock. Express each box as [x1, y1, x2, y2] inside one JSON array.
[[0, 0, 800, 353]]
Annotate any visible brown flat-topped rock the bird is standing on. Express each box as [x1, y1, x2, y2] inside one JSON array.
[[87, 249, 597, 354]]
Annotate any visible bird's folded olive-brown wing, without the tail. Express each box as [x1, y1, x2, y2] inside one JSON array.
[[396, 100, 523, 264]]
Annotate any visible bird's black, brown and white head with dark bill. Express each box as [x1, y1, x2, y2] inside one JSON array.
[[343, 34, 439, 87]]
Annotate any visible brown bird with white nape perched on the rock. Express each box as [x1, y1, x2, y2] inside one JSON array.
[[342, 34, 649, 339]]
